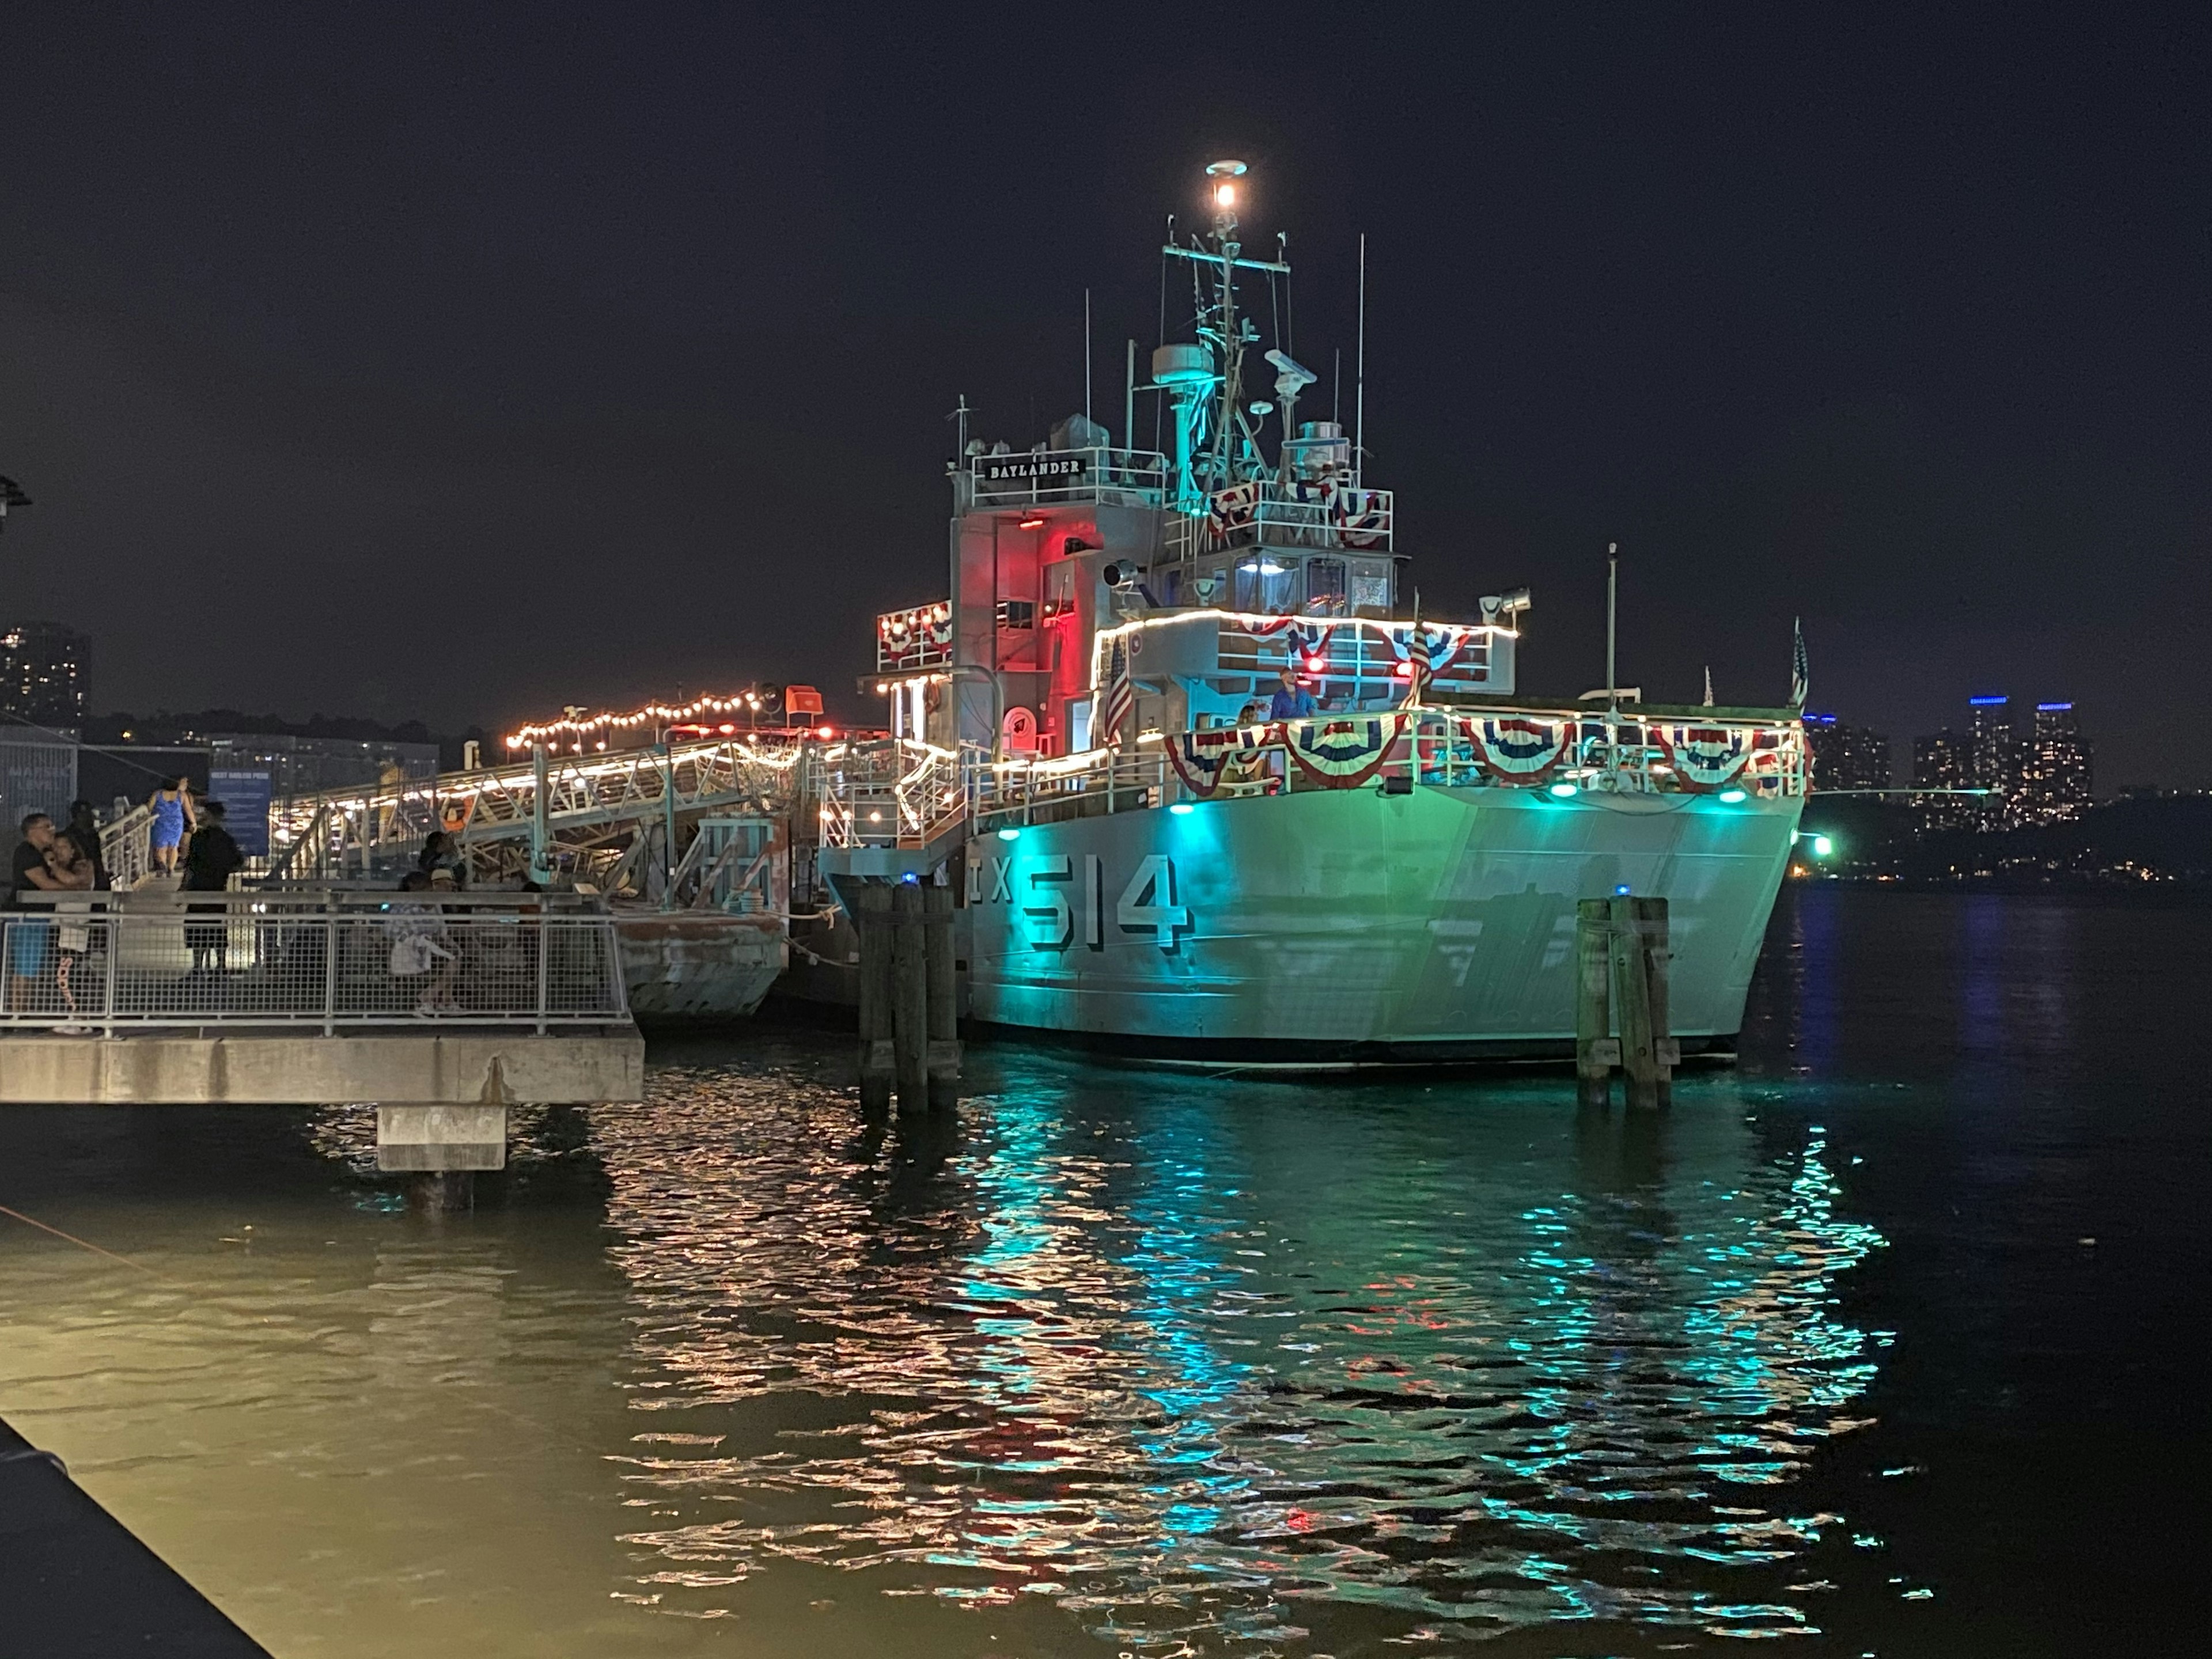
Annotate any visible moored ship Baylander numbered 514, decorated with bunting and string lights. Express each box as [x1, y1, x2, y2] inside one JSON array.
[[805, 161, 1807, 1064]]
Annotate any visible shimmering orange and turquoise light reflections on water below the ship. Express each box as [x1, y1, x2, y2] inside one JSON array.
[[593, 1062, 1883, 1650]]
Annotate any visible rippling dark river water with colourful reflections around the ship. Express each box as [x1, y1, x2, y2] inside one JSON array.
[[0, 889, 2212, 1659]]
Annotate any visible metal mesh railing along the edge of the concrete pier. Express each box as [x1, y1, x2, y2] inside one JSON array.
[[0, 893, 630, 1033]]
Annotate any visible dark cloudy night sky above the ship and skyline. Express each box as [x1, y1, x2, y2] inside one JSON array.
[[0, 5, 2212, 790]]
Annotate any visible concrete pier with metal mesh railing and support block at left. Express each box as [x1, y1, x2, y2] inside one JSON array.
[[0, 887, 643, 1196]]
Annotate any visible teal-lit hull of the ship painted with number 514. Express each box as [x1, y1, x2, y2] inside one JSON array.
[[964, 787, 1803, 1059]]
